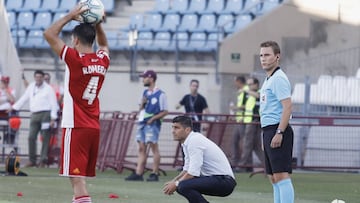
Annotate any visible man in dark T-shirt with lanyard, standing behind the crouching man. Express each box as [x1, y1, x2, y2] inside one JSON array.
[[176, 79, 209, 132]]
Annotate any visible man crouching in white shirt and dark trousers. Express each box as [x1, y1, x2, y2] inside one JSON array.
[[163, 116, 236, 203]]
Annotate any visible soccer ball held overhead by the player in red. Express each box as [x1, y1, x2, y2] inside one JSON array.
[[79, 0, 104, 24]]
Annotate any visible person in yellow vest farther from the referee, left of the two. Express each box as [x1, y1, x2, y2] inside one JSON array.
[[230, 76, 248, 169]]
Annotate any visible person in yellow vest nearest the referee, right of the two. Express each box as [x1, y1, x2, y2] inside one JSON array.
[[238, 77, 264, 172]]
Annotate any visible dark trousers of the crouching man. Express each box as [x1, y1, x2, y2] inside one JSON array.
[[176, 175, 236, 203]]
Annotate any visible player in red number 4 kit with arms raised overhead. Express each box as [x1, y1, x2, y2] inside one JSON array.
[[44, 5, 110, 203]]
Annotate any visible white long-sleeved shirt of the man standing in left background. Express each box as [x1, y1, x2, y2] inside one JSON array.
[[13, 82, 59, 119]]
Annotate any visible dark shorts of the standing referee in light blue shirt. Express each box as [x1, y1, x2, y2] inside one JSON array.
[[262, 124, 294, 174]]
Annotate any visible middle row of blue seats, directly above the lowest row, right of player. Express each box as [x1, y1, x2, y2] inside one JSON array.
[[125, 13, 253, 33]]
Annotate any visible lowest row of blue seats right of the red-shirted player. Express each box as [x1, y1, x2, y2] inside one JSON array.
[[107, 31, 219, 52]]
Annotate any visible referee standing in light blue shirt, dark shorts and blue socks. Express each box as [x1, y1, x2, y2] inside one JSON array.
[[260, 41, 294, 203]]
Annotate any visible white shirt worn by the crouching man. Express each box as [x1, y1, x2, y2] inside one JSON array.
[[182, 132, 235, 179]]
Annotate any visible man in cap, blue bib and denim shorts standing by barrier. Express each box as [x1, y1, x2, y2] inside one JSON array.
[[125, 70, 168, 181]]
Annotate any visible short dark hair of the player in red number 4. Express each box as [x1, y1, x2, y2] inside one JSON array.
[[72, 23, 96, 46]]
